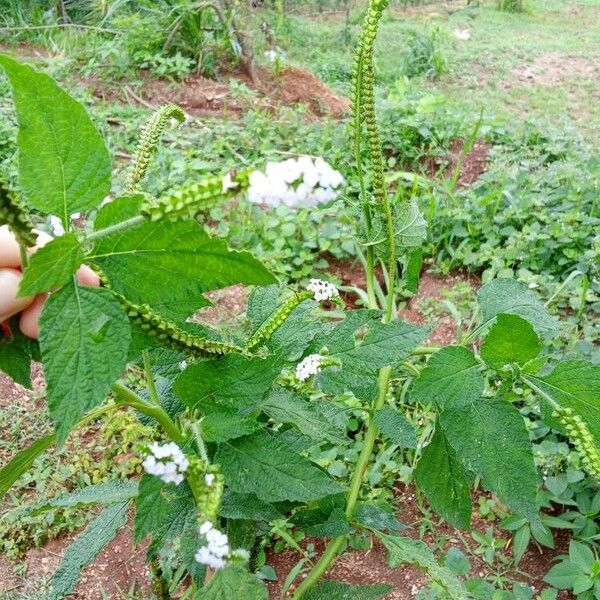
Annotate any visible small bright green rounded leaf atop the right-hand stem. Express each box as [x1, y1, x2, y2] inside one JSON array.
[[481, 314, 542, 369]]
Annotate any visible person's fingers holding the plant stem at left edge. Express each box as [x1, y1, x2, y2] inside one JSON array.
[[0, 225, 100, 339]]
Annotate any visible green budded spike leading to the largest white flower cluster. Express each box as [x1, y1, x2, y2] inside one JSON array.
[[140, 171, 249, 221]]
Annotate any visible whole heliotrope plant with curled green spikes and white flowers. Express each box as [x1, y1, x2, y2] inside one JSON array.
[[0, 0, 600, 600]]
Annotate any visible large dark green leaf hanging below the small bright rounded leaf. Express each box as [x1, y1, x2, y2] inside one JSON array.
[[440, 398, 539, 521]]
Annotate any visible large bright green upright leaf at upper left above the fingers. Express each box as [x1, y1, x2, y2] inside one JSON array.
[[0, 55, 111, 221]]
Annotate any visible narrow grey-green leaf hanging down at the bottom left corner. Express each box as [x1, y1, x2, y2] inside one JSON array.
[[49, 502, 128, 600]]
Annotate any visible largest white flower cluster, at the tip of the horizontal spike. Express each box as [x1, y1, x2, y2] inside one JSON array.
[[248, 156, 344, 208]]
